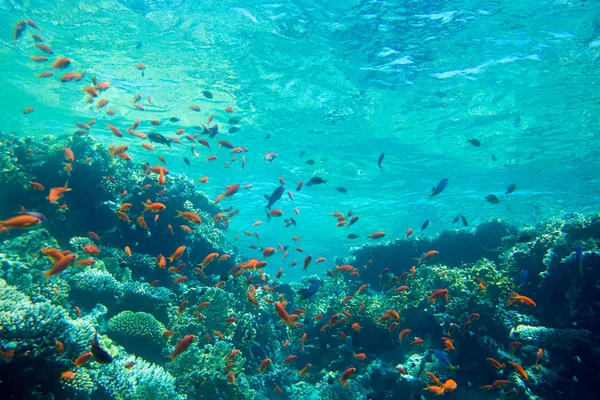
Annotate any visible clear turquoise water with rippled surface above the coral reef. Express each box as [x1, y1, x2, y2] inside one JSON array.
[[0, 0, 600, 277]]
